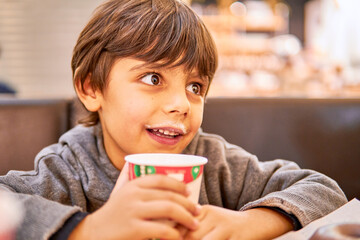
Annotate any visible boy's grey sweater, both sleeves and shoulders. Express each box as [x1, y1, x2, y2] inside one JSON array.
[[0, 125, 347, 239]]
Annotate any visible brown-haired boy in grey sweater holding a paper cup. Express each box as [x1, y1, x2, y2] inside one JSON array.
[[0, 0, 346, 240]]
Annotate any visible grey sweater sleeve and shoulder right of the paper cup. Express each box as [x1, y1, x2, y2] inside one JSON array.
[[185, 132, 347, 238]]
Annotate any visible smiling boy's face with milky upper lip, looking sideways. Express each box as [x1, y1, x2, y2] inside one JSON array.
[[97, 58, 209, 168]]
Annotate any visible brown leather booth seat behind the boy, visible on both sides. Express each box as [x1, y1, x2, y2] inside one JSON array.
[[0, 98, 360, 199]]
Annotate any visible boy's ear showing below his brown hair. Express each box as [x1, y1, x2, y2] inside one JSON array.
[[75, 74, 102, 112]]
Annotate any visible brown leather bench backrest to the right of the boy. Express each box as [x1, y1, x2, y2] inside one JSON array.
[[202, 98, 360, 199]]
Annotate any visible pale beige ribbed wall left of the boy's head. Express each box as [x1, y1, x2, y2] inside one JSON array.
[[0, 0, 102, 97]]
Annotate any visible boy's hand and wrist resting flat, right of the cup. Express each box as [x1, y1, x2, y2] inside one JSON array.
[[182, 205, 293, 240]]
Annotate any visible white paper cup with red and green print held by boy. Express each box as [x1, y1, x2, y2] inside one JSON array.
[[125, 153, 207, 203]]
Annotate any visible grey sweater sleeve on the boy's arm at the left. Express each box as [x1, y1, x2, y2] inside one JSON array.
[[0, 151, 91, 239]]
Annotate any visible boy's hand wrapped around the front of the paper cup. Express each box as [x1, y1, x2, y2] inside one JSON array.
[[69, 163, 199, 239]]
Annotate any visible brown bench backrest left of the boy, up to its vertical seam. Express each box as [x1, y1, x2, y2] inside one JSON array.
[[0, 99, 69, 175]]
